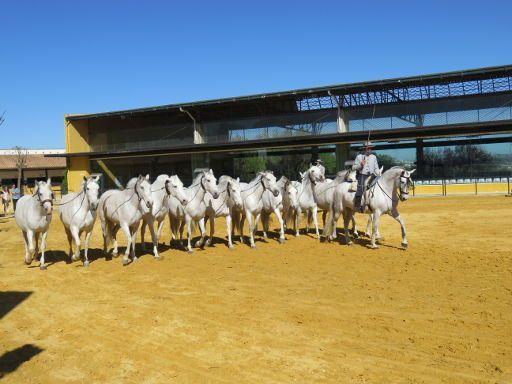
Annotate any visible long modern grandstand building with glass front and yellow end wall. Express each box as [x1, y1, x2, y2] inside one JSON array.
[[57, 66, 512, 195]]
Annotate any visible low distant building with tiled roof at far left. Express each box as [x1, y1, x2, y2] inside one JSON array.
[[0, 149, 66, 185]]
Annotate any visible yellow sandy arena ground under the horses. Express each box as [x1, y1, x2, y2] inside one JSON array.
[[0, 196, 512, 383]]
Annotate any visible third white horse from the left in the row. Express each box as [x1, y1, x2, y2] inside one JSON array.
[[98, 175, 153, 265]]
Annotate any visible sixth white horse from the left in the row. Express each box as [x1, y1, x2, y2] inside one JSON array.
[[200, 175, 243, 249]]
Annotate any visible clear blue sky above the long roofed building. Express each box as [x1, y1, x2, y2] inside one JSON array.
[[0, 0, 512, 148]]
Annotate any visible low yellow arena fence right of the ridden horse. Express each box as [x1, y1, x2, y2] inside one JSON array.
[[413, 177, 512, 196]]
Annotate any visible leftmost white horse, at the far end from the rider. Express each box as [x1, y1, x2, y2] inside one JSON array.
[[14, 179, 53, 270]]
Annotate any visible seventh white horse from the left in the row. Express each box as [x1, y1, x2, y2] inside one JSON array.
[[234, 171, 280, 248]]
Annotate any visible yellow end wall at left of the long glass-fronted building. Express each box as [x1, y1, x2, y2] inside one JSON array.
[[64, 118, 91, 192]]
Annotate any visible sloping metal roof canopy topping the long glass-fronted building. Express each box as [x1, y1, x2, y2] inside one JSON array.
[[66, 65, 512, 121]]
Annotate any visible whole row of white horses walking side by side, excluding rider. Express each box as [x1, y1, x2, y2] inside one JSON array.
[[15, 165, 414, 269]]
